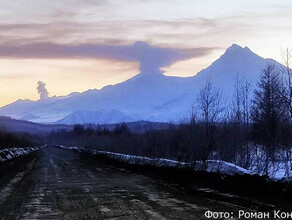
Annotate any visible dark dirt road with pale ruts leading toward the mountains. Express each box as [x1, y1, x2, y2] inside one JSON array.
[[0, 147, 288, 220]]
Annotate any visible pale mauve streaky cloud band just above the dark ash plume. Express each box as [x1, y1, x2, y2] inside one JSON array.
[[0, 18, 216, 44]]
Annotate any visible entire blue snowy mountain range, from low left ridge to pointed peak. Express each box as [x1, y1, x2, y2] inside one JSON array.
[[0, 45, 280, 124]]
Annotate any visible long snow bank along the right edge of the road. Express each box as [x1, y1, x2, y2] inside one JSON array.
[[59, 145, 292, 181]]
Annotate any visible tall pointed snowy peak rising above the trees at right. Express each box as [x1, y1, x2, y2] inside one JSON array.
[[193, 44, 280, 95]]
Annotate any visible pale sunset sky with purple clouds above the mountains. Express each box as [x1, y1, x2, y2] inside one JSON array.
[[0, 0, 292, 106]]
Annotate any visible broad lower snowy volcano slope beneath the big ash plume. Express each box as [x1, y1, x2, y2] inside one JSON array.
[[0, 71, 192, 122]]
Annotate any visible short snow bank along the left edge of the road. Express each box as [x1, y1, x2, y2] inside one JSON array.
[[0, 145, 46, 162]]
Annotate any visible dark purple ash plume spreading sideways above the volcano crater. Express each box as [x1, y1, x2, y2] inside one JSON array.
[[0, 41, 214, 73]]
